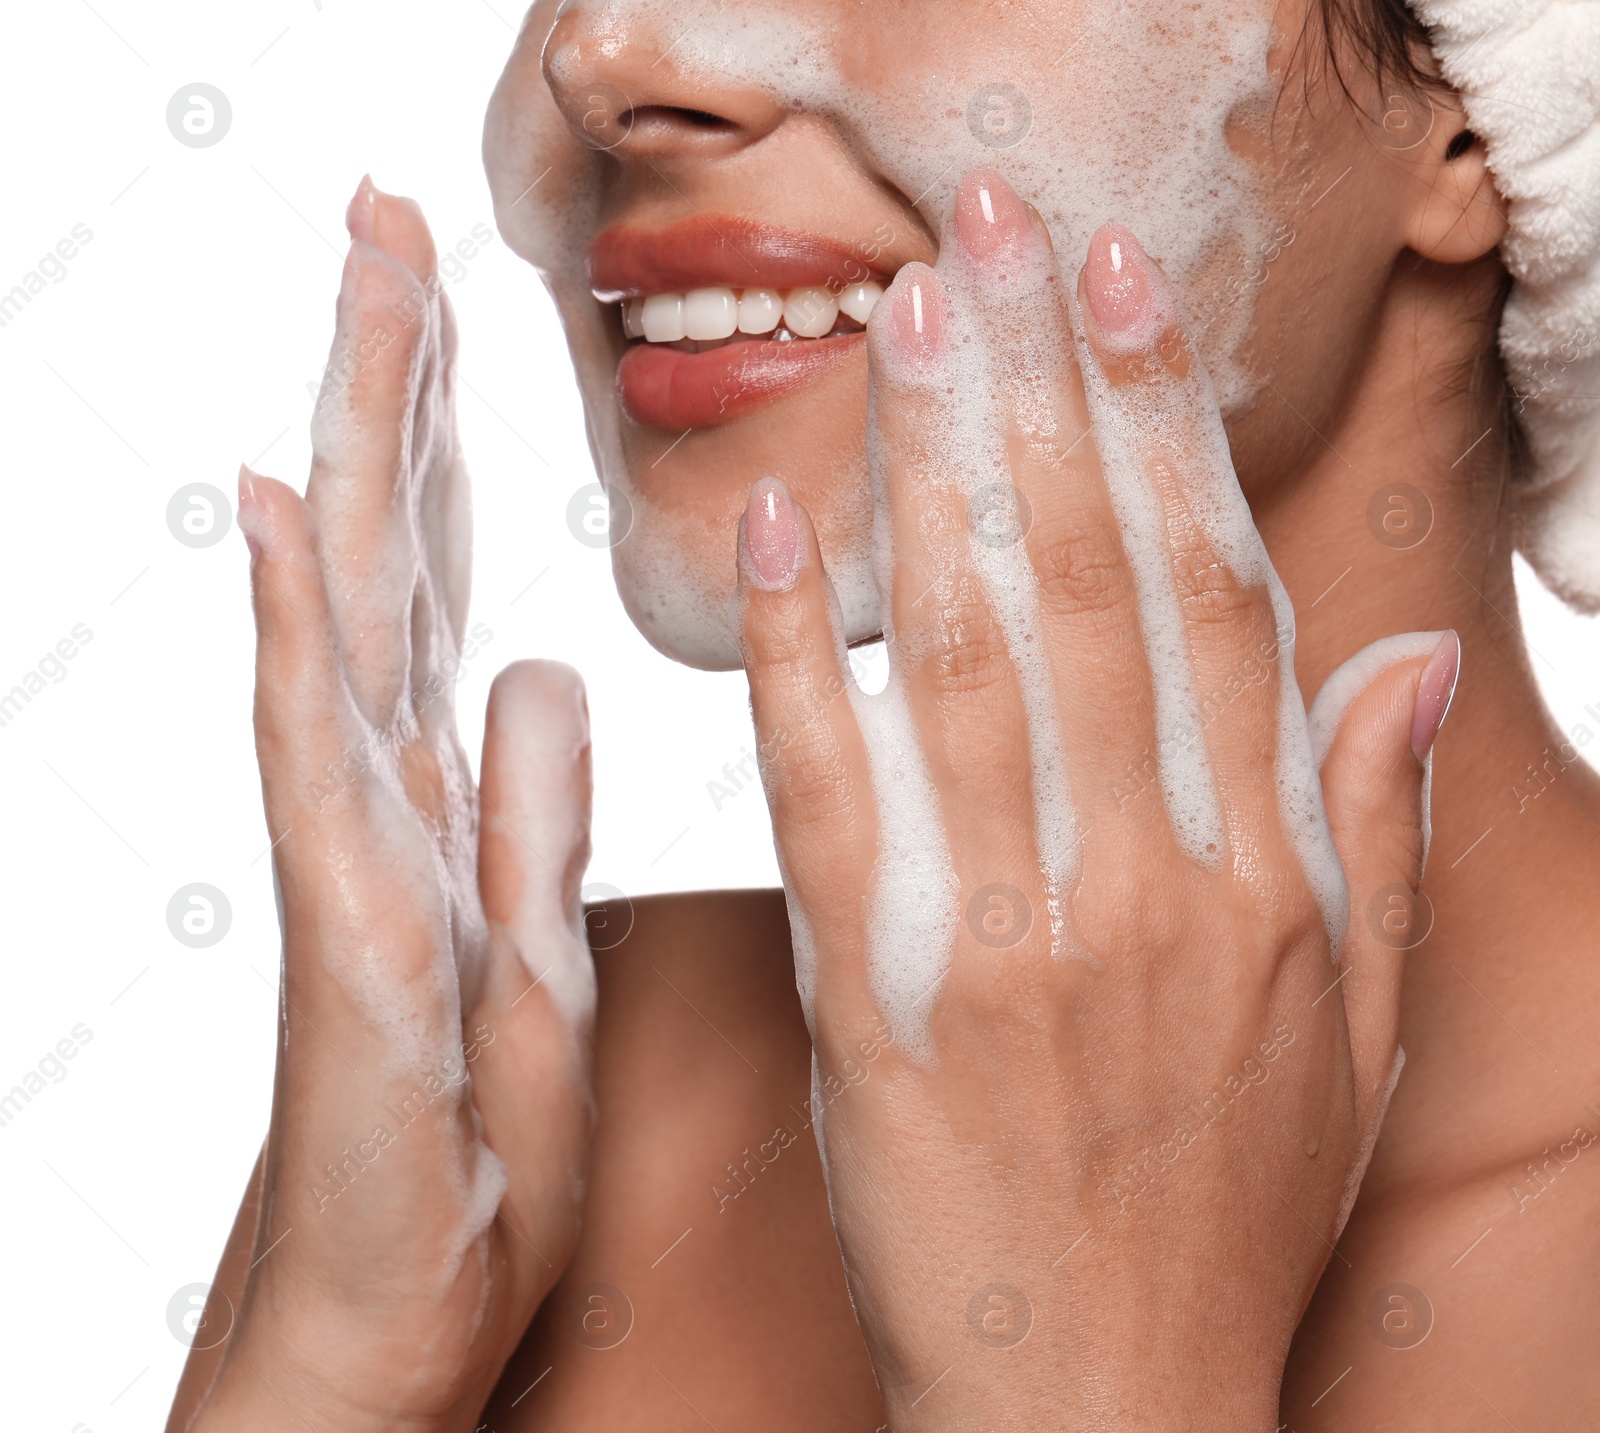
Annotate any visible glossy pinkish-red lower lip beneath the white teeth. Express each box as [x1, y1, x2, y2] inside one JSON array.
[[616, 333, 866, 429]]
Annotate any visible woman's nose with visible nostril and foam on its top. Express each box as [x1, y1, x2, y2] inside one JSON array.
[[544, 0, 786, 165]]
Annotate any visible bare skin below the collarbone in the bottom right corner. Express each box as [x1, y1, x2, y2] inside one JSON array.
[[1282, 1125, 1600, 1433]]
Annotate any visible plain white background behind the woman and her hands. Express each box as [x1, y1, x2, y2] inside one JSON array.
[[0, 0, 1600, 1433]]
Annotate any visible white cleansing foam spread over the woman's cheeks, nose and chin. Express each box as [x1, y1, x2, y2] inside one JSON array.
[[485, 0, 1275, 667]]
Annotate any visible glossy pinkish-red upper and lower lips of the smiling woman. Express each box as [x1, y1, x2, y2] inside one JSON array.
[[589, 214, 893, 430]]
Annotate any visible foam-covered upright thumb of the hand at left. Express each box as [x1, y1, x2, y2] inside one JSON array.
[[480, 662, 595, 1035]]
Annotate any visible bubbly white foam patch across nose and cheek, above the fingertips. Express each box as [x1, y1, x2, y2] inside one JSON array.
[[521, 0, 1275, 409]]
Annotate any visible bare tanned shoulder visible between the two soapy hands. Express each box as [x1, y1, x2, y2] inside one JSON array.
[[483, 891, 882, 1433]]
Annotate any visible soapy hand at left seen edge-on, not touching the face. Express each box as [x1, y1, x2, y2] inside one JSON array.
[[170, 181, 594, 1433]]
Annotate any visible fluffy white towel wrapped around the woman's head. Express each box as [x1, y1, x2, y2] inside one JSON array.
[[1413, 0, 1600, 613]]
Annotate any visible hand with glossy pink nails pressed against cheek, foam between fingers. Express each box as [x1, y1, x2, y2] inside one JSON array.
[[739, 174, 1459, 1433]]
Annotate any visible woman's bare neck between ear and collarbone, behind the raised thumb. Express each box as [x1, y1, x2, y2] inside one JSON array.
[[1256, 249, 1600, 1184]]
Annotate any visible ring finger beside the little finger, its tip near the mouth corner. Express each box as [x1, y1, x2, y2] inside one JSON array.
[[867, 264, 1043, 905]]
